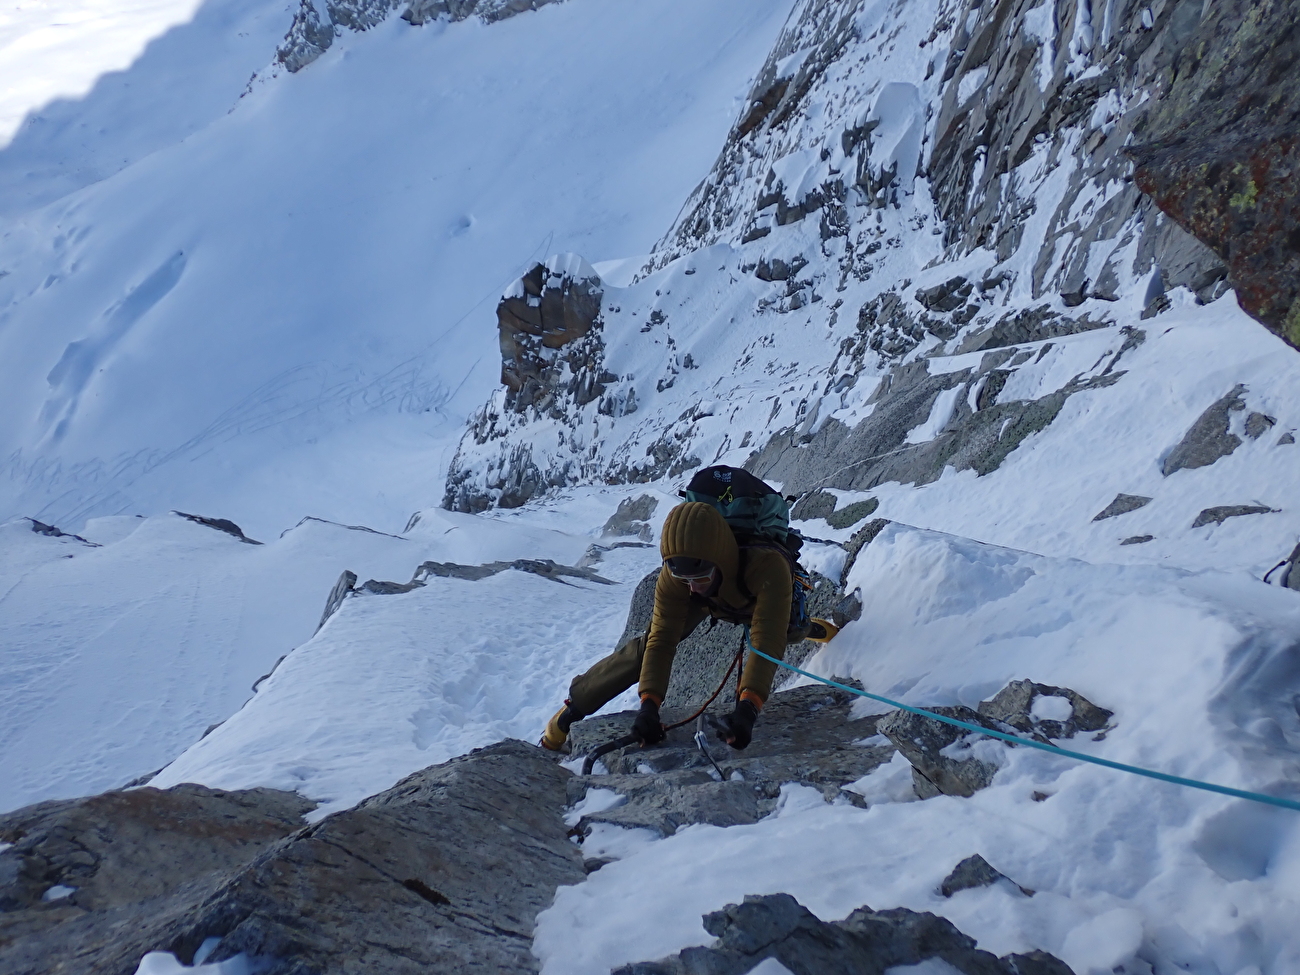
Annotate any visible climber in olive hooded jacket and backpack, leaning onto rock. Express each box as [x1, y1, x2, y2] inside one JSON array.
[[540, 467, 837, 751]]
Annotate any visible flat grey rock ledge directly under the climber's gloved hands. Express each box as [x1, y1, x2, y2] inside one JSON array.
[[569, 683, 894, 836]]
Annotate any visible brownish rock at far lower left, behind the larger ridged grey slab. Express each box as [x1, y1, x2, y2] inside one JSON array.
[[0, 785, 316, 975]]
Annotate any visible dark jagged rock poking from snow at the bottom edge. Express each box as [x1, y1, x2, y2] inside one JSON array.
[[612, 893, 1073, 975]]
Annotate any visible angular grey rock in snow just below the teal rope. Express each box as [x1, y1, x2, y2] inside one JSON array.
[[876, 705, 1005, 800]]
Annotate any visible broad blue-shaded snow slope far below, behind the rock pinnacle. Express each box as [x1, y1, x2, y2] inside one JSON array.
[[0, 0, 789, 543]]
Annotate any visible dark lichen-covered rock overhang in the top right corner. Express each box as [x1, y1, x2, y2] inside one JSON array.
[[1130, 0, 1300, 348]]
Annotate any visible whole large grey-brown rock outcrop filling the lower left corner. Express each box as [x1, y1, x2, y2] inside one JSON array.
[[0, 741, 584, 975]]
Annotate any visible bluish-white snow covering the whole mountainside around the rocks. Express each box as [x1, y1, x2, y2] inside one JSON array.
[[0, 0, 1300, 975]]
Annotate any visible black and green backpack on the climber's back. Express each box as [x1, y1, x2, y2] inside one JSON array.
[[679, 464, 813, 642]]
